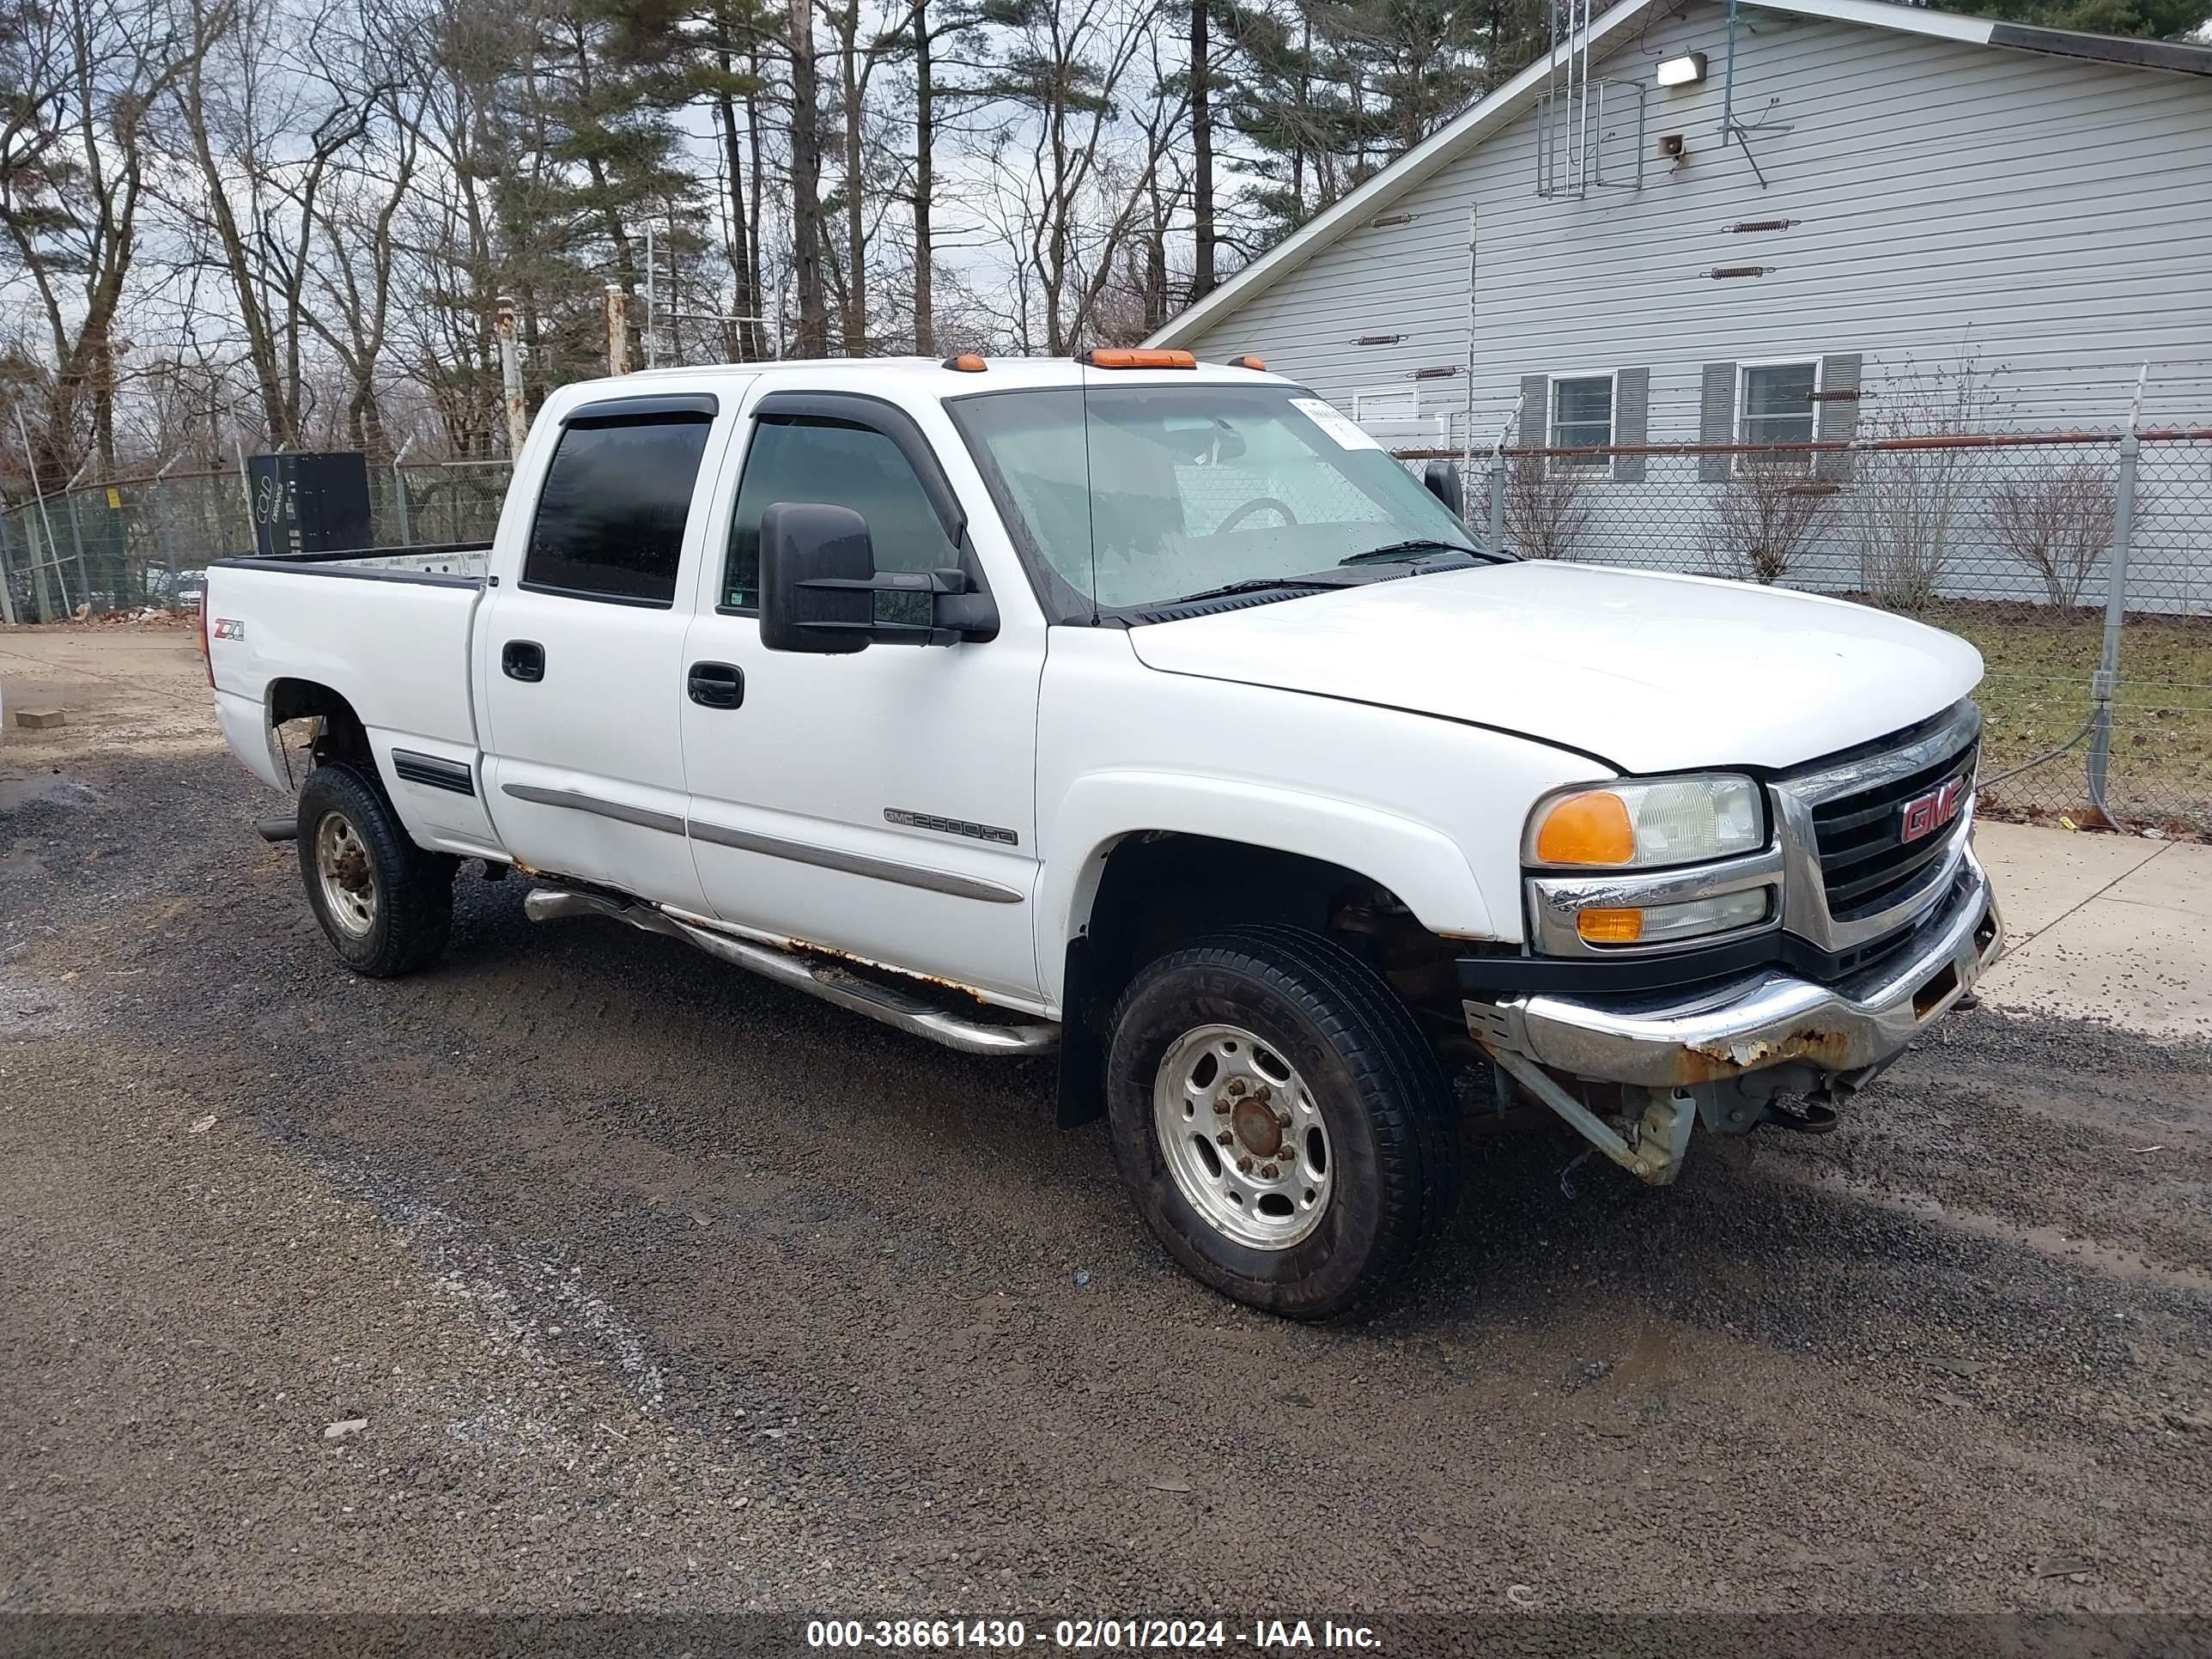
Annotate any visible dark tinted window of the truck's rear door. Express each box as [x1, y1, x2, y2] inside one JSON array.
[[522, 416, 708, 604]]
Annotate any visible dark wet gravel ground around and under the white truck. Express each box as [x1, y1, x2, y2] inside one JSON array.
[[0, 641, 2212, 1614]]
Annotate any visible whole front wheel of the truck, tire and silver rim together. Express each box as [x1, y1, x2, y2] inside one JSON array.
[[1106, 927, 1458, 1318]]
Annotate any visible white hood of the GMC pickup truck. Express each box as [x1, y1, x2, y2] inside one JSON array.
[[1130, 560, 1982, 772]]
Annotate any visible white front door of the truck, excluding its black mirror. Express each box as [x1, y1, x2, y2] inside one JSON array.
[[681, 392, 1044, 1002]]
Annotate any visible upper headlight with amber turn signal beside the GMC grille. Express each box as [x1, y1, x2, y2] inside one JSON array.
[[1524, 772, 1767, 869]]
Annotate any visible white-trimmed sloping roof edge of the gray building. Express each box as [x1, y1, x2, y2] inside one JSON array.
[[1146, 0, 2212, 345]]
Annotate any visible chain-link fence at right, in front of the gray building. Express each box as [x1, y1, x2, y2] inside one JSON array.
[[1398, 429, 2212, 834]]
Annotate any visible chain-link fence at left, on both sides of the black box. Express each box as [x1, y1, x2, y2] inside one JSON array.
[[0, 460, 508, 622]]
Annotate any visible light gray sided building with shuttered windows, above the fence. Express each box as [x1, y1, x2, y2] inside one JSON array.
[[1152, 0, 2212, 611]]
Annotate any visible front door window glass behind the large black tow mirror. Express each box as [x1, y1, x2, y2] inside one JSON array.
[[721, 416, 960, 611]]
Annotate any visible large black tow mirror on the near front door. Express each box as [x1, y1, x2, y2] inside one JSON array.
[[761, 502, 998, 654]]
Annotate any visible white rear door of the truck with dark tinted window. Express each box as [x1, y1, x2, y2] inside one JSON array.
[[476, 394, 721, 909]]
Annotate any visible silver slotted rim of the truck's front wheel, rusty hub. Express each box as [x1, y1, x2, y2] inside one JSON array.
[[1152, 1024, 1336, 1249]]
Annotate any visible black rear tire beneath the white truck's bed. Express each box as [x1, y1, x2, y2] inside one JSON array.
[[299, 761, 460, 980]]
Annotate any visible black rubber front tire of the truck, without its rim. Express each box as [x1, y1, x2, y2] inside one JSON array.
[[1106, 927, 1460, 1321]]
